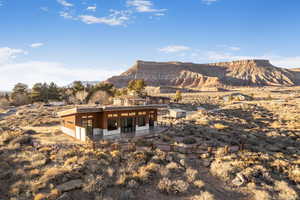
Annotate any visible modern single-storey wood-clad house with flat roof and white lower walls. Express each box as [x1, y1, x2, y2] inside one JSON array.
[[58, 105, 162, 141]]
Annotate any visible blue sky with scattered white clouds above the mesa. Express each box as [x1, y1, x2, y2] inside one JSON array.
[[0, 0, 300, 90]]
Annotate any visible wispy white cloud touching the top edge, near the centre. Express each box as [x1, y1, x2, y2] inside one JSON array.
[[127, 0, 167, 13]]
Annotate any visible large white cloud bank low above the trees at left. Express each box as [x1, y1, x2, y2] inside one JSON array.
[[0, 61, 121, 90]]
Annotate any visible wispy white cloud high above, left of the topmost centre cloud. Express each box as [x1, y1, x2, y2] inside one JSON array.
[[79, 10, 130, 26]]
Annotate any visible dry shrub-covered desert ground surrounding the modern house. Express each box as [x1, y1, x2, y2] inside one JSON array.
[[0, 87, 300, 200]]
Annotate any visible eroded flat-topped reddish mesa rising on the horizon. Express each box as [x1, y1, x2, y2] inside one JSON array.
[[107, 60, 300, 88]]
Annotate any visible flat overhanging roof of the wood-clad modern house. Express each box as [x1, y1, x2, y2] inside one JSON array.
[[57, 104, 167, 117]]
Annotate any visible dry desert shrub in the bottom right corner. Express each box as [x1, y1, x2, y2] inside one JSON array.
[[275, 181, 298, 200]]
